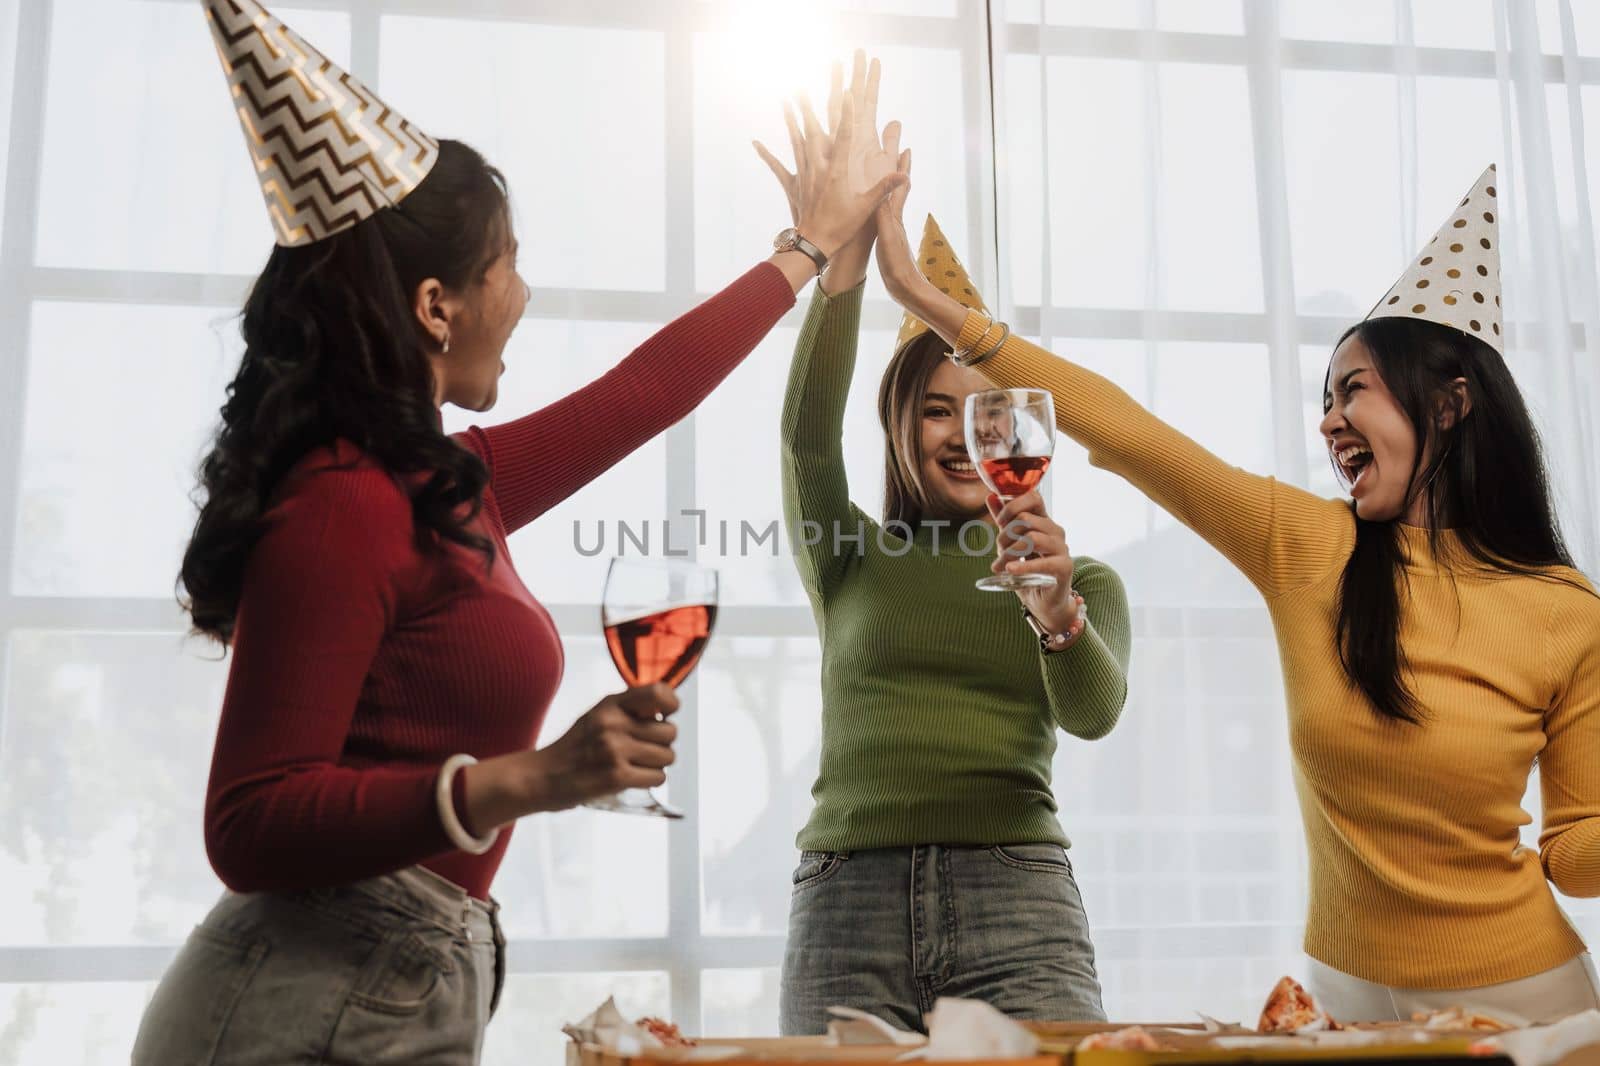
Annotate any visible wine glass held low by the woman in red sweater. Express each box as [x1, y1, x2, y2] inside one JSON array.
[[586, 559, 717, 818]]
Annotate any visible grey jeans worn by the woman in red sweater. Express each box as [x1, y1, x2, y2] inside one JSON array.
[[133, 866, 506, 1066]]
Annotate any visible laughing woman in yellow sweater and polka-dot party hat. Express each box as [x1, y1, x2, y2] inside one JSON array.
[[878, 160, 1600, 1021]]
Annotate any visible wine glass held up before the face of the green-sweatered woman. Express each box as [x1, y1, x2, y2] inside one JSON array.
[[966, 389, 1056, 592]]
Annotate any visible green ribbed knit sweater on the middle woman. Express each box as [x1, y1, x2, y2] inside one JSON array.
[[782, 285, 1131, 852]]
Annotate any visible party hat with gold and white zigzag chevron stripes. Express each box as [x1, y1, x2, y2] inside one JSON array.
[[202, 0, 438, 246]]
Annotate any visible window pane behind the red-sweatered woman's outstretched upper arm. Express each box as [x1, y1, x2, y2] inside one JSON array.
[[445, 319, 669, 605]]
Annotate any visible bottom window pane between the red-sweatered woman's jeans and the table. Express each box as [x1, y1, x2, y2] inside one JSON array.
[[483, 973, 668, 1066]]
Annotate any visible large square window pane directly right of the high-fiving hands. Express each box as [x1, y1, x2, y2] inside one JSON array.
[[1005, 56, 1261, 311]]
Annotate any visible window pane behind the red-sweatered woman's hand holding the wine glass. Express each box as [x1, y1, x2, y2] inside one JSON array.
[[494, 633, 662, 934]]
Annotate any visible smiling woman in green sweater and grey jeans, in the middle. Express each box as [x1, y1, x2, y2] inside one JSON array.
[[762, 62, 1130, 1034]]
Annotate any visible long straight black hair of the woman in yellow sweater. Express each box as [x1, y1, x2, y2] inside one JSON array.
[[1323, 319, 1578, 723]]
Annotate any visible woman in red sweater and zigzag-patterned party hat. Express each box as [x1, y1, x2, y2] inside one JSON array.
[[133, 0, 899, 1066]]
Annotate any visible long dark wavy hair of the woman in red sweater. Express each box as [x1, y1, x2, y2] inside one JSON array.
[[178, 141, 510, 647]]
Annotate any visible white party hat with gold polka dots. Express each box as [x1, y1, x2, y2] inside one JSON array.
[[1366, 165, 1506, 355]]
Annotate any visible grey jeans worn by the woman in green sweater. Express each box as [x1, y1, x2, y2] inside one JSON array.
[[779, 844, 1106, 1036]]
